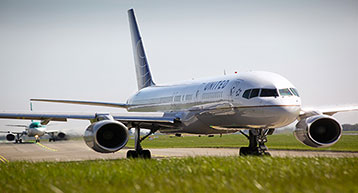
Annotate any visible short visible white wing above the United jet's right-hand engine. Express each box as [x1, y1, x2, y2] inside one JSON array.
[[300, 105, 358, 117]]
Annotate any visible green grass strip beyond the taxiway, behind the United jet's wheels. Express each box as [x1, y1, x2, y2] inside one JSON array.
[[128, 134, 358, 151]]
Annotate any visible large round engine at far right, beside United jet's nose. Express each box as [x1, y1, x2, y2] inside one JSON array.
[[294, 115, 342, 147]]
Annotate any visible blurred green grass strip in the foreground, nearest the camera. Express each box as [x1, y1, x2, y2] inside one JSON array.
[[0, 157, 358, 193]]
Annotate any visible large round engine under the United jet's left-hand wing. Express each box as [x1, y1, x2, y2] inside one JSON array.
[[84, 120, 129, 153]]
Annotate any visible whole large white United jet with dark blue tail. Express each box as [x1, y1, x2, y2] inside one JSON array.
[[0, 9, 358, 158]]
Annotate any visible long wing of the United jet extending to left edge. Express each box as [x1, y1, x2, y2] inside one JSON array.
[[0, 112, 180, 128]]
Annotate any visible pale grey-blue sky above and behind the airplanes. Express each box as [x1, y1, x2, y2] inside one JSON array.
[[0, 0, 358, 133]]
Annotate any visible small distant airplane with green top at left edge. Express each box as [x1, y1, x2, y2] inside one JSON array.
[[0, 121, 66, 143]]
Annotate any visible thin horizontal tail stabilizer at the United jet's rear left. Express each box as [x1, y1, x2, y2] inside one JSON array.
[[30, 99, 129, 108]]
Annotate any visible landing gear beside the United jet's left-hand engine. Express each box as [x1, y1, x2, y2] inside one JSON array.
[[127, 127, 156, 159]]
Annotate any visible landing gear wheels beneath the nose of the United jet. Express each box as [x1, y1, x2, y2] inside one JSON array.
[[240, 129, 275, 156]]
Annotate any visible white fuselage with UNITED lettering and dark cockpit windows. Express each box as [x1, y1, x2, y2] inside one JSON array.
[[127, 72, 301, 133]]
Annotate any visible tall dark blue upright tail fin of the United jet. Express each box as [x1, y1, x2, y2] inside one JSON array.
[[128, 9, 155, 90]]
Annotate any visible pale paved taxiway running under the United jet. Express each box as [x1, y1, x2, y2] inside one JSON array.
[[0, 140, 358, 162]]
